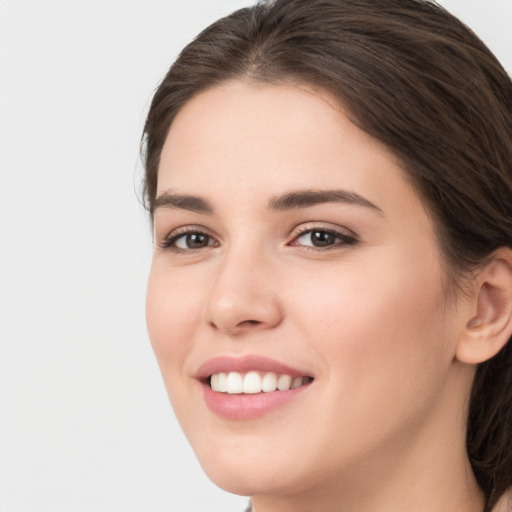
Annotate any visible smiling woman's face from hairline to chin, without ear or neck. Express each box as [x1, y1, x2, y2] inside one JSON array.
[[147, 82, 470, 495]]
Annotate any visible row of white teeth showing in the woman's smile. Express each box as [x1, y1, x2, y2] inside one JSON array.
[[210, 371, 311, 395]]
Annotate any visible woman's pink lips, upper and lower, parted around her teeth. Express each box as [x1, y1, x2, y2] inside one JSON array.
[[196, 355, 310, 420]]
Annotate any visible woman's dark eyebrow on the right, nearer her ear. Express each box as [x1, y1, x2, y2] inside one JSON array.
[[268, 189, 384, 215]]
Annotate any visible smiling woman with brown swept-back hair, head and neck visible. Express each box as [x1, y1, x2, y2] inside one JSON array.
[[144, 0, 512, 512]]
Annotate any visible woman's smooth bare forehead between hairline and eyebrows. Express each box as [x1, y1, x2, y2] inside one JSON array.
[[157, 81, 428, 220]]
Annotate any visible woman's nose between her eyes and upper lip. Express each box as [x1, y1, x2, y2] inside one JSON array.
[[203, 251, 283, 336]]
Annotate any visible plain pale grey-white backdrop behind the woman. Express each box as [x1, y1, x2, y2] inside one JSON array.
[[0, 0, 512, 512]]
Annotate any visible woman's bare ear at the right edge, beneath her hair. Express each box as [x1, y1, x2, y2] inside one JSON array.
[[455, 247, 512, 364]]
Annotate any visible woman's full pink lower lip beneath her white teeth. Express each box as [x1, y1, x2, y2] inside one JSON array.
[[202, 383, 311, 420]]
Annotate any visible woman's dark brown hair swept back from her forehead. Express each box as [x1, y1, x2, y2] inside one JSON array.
[[143, 0, 512, 512]]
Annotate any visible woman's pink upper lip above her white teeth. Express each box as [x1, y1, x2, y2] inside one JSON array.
[[196, 355, 312, 380]]
